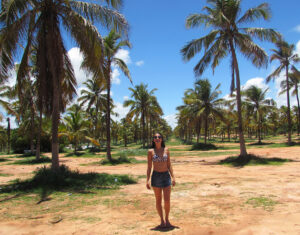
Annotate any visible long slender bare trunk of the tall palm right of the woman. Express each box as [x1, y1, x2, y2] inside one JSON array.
[[230, 39, 247, 160]]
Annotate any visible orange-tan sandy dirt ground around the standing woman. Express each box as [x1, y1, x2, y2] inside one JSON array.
[[0, 147, 300, 235]]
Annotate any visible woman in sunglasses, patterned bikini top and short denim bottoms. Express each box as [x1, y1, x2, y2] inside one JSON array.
[[146, 133, 175, 228]]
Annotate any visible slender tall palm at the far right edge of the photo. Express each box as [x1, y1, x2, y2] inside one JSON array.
[[267, 40, 300, 145]]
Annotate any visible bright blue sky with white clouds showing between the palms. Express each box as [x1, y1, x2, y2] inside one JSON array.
[[0, 0, 300, 127]]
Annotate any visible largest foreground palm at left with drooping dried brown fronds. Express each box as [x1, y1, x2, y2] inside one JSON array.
[[0, 0, 128, 171]]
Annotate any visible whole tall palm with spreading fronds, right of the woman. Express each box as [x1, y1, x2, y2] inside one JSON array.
[[181, 0, 279, 160]]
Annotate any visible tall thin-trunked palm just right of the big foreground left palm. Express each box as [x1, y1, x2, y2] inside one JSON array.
[[83, 30, 132, 161]]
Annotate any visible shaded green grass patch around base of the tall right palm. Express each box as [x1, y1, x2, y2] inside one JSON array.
[[220, 154, 292, 167]]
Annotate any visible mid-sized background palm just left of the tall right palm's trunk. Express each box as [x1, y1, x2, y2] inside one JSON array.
[[184, 79, 223, 144]]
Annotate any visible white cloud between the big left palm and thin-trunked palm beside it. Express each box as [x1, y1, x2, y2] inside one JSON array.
[[68, 47, 87, 86]]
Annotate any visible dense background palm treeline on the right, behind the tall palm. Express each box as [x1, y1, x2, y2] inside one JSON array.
[[174, 79, 300, 144]]
